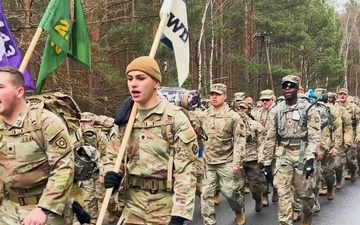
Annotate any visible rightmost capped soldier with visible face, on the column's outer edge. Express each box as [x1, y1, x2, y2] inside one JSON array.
[[328, 92, 354, 190]]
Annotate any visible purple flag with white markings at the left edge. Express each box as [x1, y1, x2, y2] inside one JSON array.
[[0, 0, 35, 90]]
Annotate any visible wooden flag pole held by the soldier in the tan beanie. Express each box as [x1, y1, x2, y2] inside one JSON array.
[[96, 13, 169, 225]]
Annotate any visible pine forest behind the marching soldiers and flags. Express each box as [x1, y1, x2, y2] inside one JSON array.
[[3, 0, 360, 116]]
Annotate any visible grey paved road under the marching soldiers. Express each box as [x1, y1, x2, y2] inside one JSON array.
[[104, 178, 360, 225]]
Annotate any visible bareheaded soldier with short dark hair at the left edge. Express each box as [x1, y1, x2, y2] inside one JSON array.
[[0, 67, 74, 225]]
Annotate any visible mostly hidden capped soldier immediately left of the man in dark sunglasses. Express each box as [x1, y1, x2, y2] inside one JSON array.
[[251, 90, 278, 207]]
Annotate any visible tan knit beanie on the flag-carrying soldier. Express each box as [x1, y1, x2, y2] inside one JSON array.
[[126, 56, 161, 83]]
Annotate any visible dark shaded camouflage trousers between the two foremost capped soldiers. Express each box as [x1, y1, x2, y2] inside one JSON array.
[[243, 161, 267, 200]]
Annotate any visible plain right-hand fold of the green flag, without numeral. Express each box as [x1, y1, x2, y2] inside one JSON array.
[[68, 0, 91, 69]]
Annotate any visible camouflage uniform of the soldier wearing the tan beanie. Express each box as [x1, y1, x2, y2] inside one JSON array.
[[112, 100, 198, 225]]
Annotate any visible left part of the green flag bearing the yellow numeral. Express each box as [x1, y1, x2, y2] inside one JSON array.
[[35, 0, 71, 94]]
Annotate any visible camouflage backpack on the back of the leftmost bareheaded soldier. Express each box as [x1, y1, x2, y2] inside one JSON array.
[[26, 92, 83, 149]]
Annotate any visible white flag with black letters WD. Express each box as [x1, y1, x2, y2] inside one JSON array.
[[160, 0, 190, 87]]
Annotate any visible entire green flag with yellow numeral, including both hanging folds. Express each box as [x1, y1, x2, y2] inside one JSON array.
[[36, 0, 91, 94]]
